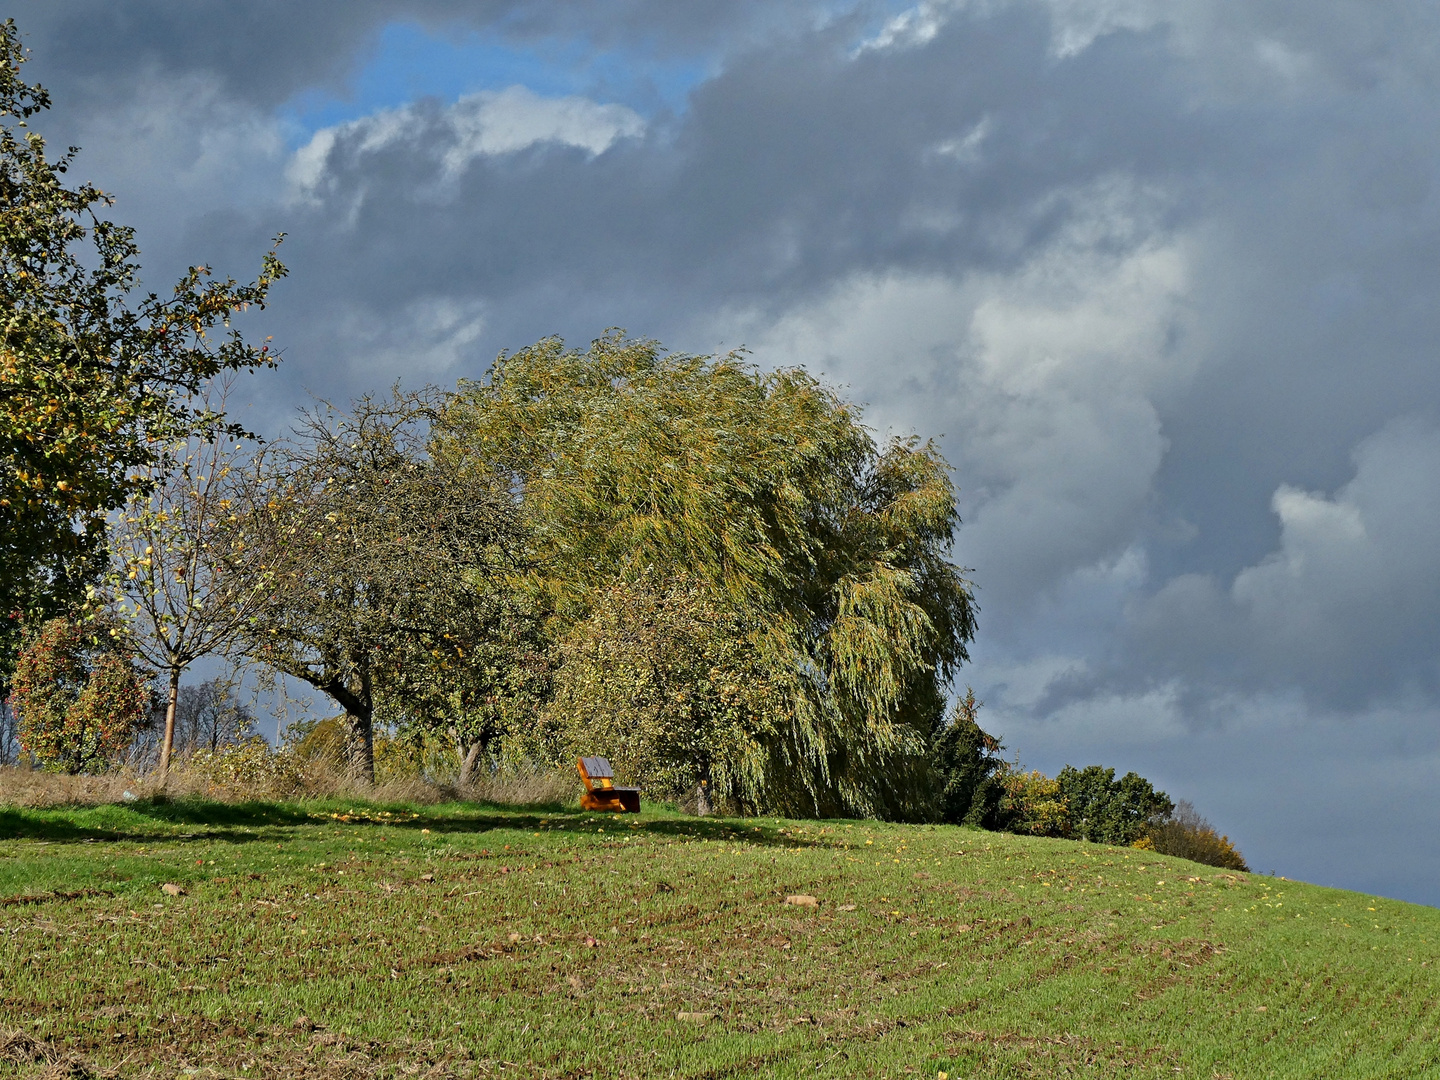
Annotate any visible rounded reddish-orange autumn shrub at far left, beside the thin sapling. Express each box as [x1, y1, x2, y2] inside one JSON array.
[[10, 619, 150, 773]]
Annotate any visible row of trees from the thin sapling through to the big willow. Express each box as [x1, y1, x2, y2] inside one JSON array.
[[19, 334, 975, 819]]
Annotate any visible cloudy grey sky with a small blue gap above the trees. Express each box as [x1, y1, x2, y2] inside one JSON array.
[[10, 0, 1440, 904]]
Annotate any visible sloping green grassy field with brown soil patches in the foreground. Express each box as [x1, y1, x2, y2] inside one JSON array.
[[0, 802, 1440, 1080]]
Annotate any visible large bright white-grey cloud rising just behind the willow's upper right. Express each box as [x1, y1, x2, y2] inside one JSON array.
[[724, 186, 1194, 615]]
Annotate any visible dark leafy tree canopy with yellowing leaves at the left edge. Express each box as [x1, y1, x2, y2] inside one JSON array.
[[0, 20, 285, 683]]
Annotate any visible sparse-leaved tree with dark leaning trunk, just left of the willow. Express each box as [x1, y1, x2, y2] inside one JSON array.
[[233, 393, 526, 782]]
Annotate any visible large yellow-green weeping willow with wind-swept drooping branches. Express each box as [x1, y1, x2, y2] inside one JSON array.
[[436, 333, 975, 816]]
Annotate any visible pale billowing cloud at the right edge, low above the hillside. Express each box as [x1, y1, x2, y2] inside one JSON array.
[[1128, 419, 1440, 714]]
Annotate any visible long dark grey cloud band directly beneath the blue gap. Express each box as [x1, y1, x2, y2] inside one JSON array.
[[256, 10, 1192, 342]]
